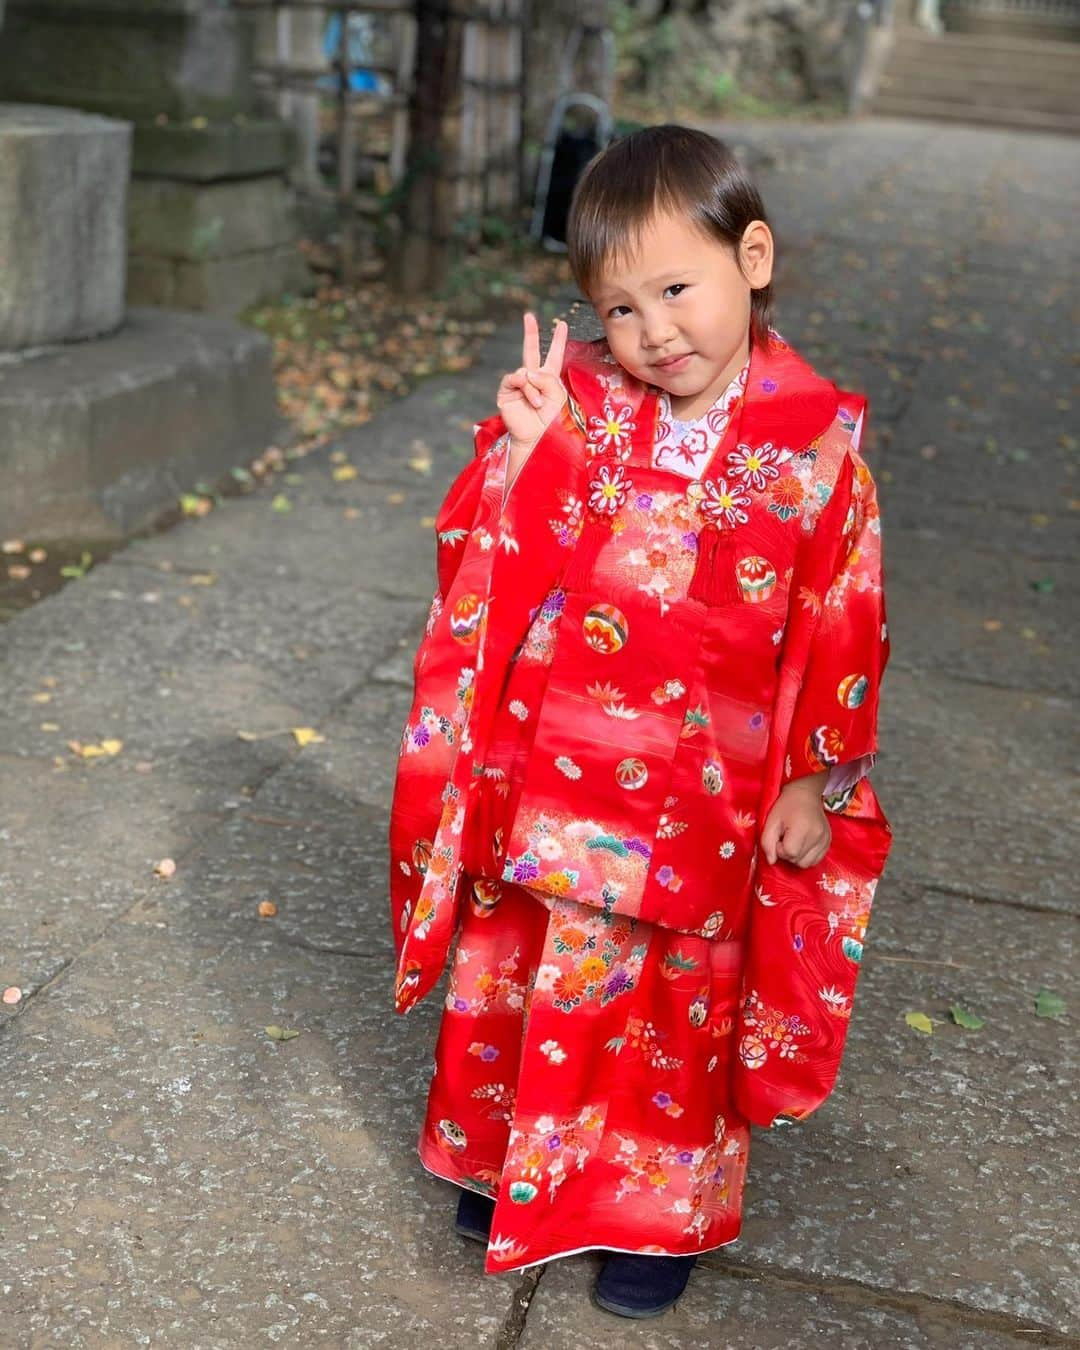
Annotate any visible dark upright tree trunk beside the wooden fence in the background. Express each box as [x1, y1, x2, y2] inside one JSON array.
[[394, 0, 464, 296]]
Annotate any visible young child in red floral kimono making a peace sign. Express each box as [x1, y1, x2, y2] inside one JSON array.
[[390, 127, 888, 1316]]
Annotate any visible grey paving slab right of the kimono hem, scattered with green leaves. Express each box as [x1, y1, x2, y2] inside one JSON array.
[[730, 884, 1080, 1334]]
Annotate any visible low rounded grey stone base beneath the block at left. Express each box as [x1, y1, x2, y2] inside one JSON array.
[[0, 309, 282, 541]]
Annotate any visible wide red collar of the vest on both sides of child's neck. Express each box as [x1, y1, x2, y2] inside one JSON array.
[[563, 328, 840, 461]]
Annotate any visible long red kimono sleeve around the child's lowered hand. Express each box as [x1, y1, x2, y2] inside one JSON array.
[[733, 434, 890, 1126]]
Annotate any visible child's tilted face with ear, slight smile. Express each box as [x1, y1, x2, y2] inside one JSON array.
[[590, 213, 772, 417]]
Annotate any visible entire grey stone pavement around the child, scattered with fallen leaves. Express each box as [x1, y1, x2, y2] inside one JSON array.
[[0, 122, 1080, 1350]]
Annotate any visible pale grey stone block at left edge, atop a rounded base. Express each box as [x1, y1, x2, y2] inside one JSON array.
[[0, 104, 131, 350]]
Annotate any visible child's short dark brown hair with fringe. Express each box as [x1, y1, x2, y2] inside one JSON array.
[[567, 124, 772, 346]]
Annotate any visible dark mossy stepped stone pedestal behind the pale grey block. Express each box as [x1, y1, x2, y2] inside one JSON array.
[[0, 0, 309, 313]]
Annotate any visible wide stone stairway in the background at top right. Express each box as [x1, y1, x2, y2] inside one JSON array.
[[867, 27, 1080, 134]]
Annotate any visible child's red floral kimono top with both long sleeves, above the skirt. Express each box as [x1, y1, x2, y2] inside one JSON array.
[[390, 332, 890, 1125]]
